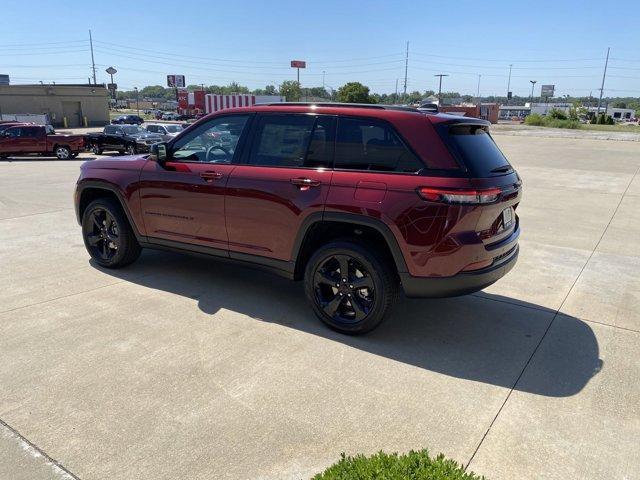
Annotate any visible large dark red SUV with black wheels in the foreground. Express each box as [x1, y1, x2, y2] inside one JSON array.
[[75, 104, 522, 333]]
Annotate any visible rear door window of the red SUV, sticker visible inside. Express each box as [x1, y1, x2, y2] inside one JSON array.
[[249, 115, 316, 167]]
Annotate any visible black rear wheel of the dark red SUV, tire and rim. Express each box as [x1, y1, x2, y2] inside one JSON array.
[[304, 239, 398, 335]]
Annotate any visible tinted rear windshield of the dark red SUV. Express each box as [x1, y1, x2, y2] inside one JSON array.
[[449, 125, 513, 178]]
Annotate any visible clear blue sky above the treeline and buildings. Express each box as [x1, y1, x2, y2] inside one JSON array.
[[0, 0, 640, 96]]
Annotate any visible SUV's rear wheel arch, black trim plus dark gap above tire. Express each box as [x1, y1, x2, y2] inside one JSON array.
[[291, 212, 407, 280]]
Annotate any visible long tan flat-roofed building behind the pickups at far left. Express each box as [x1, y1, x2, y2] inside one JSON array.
[[0, 84, 109, 128]]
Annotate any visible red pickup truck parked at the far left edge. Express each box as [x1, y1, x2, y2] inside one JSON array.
[[0, 124, 85, 160]]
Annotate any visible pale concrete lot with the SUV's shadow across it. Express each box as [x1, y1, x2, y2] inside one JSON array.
[[0, 135, 640, 480]]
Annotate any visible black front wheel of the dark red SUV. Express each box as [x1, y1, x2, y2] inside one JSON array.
[[82, 198, 142, 268]]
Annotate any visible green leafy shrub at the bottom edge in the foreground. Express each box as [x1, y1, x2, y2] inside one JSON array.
[[313, 450, 484, 480]]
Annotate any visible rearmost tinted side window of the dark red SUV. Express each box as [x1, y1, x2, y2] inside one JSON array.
[[335, 118, 424, 173]]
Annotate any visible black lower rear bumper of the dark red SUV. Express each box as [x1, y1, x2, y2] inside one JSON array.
[[400, 244, 520, 298]]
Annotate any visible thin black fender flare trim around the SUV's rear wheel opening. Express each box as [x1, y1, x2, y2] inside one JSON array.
[[291, 212, 408, 273]]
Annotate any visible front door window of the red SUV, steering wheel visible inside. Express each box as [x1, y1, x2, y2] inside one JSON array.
[[172, 115, 249, 163]]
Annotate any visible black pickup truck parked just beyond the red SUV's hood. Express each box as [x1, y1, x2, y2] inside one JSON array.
[[86, 125, 162, 155]]
